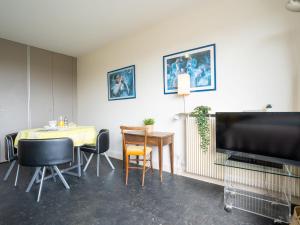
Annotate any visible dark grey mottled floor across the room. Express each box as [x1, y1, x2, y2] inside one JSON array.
[[0, 158, 273, 225]]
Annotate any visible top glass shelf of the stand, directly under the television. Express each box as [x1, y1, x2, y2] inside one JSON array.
[[214, 153, 300, 178]]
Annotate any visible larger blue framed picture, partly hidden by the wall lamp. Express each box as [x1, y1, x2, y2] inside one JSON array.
[[163, 44, 216, 94]]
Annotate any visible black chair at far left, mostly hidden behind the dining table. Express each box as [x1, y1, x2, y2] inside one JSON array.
[[3, 133, 18, 181]]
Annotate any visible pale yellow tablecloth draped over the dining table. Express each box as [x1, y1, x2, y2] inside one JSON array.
[[15, 126, 97, 148]]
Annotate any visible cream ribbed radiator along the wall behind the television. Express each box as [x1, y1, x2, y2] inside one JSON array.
[[186, 117, 300, 198]]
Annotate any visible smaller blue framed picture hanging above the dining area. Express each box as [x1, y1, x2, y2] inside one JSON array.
[[107, 65, 136, 101]]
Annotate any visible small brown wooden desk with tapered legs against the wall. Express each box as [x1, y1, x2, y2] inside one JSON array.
[[123, 131, 174, 181]]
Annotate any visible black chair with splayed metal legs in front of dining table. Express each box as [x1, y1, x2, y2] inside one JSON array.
[[16, 138, 73, 202]]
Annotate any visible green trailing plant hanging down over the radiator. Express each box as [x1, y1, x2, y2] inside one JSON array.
[[191, 105, 211, 152]]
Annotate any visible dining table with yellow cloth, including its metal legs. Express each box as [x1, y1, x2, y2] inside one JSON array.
[[14, 126, 97, 178]]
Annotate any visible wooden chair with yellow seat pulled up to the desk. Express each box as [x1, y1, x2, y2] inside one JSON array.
[[120, 126, 153, 186]]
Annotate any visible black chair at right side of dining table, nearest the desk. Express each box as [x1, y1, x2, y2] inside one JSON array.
[[80, 129, 115, 176]]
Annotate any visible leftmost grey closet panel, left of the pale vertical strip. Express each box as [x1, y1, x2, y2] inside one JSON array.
[[0, 39, 28, 161]]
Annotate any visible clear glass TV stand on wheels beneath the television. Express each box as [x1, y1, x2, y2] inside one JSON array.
[[215, 153, 299, 223]]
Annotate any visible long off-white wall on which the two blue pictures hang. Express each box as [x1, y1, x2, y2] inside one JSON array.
[[78, 0, 300, 173]]
